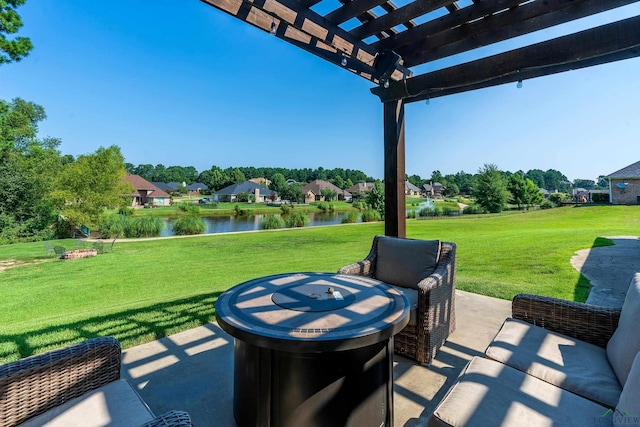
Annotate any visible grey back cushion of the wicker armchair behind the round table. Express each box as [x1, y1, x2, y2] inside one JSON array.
[[375, 236, 440, 289]]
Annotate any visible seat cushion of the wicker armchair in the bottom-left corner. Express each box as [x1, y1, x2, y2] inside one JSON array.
[[20, 379, 154, 427]]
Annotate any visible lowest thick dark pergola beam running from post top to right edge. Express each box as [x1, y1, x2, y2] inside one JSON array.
[[371, 16, 640, 103]]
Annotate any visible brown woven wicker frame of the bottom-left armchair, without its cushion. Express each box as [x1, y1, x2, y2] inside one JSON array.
[[0, 337, 192, 427]]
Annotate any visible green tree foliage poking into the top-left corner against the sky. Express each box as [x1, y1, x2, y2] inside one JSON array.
[[0, 0, 33, 65]]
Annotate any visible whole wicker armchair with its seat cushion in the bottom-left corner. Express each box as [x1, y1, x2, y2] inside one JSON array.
[[0, 337, 192, 427]]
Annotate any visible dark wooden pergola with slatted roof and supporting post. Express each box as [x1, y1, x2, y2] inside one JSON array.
[[201, 0, 640, 237]]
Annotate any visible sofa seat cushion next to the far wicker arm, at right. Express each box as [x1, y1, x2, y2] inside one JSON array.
[[485, 319, 622, 408]]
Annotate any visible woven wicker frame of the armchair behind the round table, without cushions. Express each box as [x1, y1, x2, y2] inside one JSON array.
[[338, 236, 456, 364]]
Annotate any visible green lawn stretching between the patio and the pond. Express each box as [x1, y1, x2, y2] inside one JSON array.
[[0, 206, 640, 362]]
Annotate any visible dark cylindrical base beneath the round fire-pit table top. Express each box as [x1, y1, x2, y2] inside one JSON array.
[[233, 337, 393, 427]]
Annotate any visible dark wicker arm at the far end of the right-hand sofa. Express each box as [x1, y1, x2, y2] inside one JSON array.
[[512, 294, 621, 347]]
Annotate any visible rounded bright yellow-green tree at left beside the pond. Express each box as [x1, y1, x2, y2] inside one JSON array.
[[52, 145, 133, 226]]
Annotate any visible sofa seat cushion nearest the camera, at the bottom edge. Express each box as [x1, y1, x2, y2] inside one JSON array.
[[429, 357, 612, 427]]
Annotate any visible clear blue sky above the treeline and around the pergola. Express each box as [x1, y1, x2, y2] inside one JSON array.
[[0, 0, 640, 180]]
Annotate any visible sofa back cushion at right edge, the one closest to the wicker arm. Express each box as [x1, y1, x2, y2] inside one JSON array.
[[607, 273, 640, 386]]
